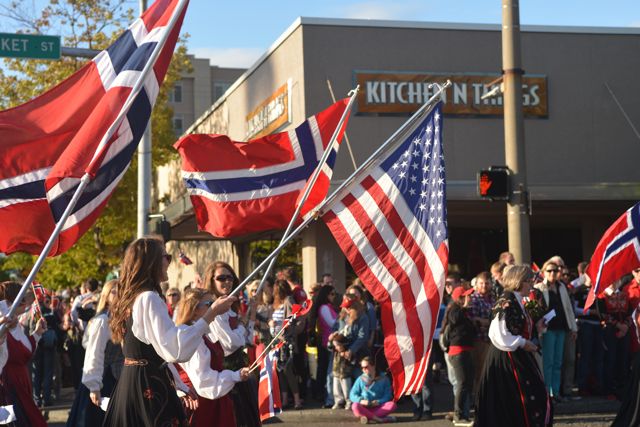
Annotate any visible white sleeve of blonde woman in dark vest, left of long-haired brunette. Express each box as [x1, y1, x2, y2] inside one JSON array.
[[82, 314, 111, 392]]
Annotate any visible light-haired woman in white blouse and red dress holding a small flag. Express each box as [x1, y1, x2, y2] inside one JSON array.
[[177, 289, 249, 427]]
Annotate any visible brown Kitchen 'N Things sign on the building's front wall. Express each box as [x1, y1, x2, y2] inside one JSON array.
[[354, 71, 548, 117]]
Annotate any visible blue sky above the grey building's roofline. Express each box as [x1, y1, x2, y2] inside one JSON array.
[[183, 0, 640, 67]]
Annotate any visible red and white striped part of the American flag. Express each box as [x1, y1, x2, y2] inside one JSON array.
[[323, 168, 449, 399]]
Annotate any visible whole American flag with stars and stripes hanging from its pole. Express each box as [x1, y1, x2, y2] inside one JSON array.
[[323, 102, 449, 400]]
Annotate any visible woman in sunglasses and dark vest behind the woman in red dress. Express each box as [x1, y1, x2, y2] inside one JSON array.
[[204, 261, 261, 427]]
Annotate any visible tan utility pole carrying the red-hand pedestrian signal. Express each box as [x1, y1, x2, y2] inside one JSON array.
[[502, 0, 531, 264]]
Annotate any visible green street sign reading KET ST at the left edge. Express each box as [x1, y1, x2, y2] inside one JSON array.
[[0, 33, 60, 59]]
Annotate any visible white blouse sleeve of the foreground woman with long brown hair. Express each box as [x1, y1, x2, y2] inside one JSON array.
[[131, 291, 209, 363]]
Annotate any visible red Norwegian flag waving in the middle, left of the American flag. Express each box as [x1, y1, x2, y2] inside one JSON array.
[[174, 99, 348, 238]]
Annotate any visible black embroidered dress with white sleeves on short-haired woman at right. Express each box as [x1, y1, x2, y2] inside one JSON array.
[[475, 291, 553, 427]]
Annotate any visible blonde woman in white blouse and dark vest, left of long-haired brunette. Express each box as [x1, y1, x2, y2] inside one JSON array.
[[67, 280, 124, 427]]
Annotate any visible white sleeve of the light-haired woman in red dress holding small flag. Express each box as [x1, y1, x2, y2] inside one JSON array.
[[180, 341, 240, 400]]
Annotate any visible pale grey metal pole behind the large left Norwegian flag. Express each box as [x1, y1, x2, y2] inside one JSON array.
[[138, 0, 151, 237]]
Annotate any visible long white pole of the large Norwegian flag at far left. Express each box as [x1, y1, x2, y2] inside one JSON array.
[[0, 0, 187, 336]]
